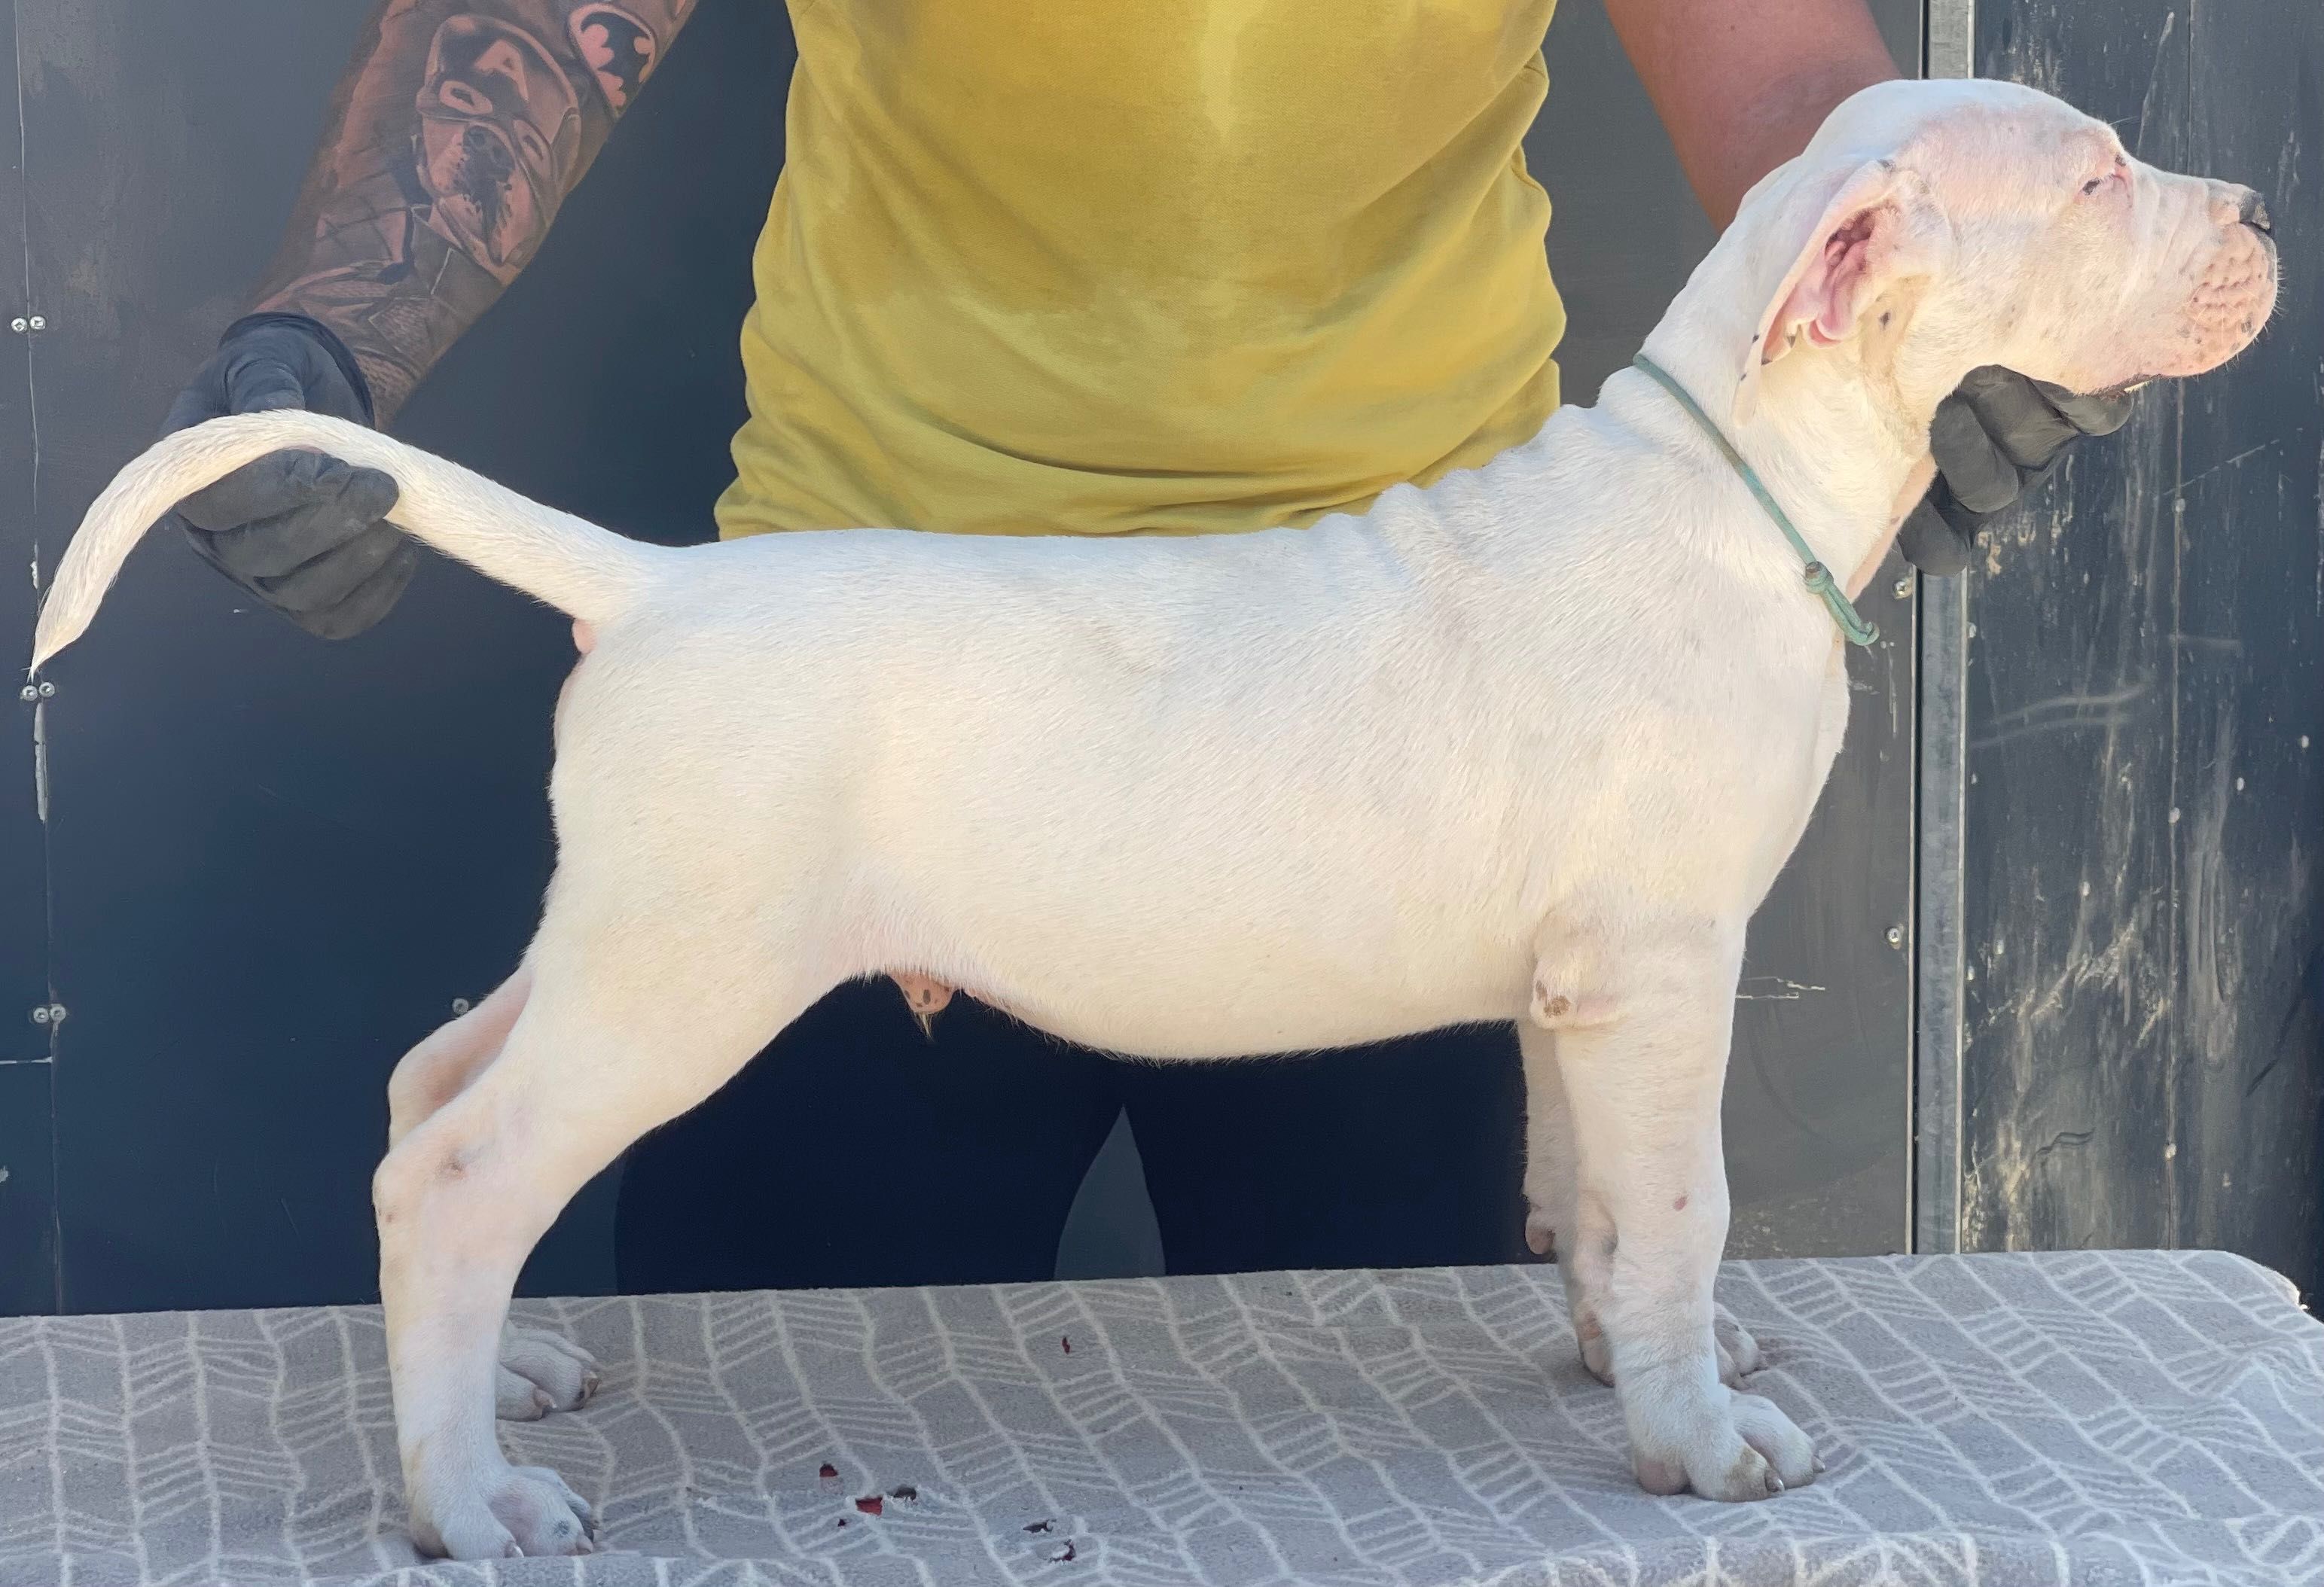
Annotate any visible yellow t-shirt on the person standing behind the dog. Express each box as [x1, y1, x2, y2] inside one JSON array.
[[718, 0, 1564, 537]]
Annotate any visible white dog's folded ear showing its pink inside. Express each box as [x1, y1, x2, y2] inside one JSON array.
[[1734, 160, 1929, 425]]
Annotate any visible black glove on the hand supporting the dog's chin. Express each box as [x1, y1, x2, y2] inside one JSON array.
[[1896, 365, 2131, 574]]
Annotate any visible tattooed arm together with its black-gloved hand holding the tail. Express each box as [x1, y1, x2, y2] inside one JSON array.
[[163, 0, 695, 639]]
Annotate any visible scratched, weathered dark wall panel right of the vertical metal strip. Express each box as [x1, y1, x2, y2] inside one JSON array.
[[1962, 0, 2324, 1292]]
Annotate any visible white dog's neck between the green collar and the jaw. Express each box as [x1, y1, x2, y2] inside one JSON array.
[[1601, 242, 1936, 597]]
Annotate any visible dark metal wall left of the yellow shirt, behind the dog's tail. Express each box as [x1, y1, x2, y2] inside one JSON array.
[[0, 0, 788, 1311]]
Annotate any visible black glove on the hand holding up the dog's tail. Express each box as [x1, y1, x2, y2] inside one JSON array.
[[163, 314, 421, 639]]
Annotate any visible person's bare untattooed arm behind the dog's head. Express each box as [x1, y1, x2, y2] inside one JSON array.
[[1606, 0, 1896, 225]]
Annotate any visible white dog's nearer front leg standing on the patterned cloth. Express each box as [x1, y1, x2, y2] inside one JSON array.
[[1527, 934, 1815, 1499]]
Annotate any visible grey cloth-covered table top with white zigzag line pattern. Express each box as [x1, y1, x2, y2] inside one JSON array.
[[0, 1253, 2324, 1587]]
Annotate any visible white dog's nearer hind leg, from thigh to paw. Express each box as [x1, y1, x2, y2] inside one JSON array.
[[374, 892, 825, 1559]]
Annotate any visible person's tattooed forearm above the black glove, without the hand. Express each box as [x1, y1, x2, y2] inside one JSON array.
[[255, 0, 695, 423]]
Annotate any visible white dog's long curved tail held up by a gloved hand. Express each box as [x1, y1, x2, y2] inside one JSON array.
[[32, 411, 672, 669]]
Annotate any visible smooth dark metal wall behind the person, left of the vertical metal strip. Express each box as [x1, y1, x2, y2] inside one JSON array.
[[0, 0, 1917, 1311]]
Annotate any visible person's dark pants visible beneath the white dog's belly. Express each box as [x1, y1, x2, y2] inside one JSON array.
[[616, 980, 1524, 1294]]
